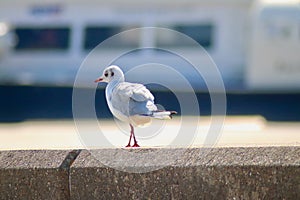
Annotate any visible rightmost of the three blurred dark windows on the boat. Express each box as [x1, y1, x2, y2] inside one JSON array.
[[157, 24, 214, 48]]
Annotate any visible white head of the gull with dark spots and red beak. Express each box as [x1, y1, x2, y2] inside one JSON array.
[[95, 65, 124, 83]]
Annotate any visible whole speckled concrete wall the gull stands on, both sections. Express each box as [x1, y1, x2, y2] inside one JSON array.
[[0, 147, 300, 199]]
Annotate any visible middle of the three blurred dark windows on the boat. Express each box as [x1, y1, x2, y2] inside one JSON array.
[[84, 26, 139, 50]]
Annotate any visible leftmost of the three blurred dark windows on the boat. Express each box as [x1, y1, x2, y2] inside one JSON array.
[[15, 27, 70, 50]]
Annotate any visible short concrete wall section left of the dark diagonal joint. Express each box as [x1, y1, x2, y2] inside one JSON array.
[[0, 150, 70, 200]]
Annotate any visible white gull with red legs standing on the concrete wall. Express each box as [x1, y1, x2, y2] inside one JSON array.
[[95, 65, 177, 147]]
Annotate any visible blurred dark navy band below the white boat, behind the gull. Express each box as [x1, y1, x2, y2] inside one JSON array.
[[0, 86, 300, 122]]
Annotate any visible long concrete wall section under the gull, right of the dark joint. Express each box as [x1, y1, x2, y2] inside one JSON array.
[[70, 147, 300, 199]]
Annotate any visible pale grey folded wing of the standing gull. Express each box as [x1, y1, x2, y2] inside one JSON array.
[[111, 82, 157, 116]]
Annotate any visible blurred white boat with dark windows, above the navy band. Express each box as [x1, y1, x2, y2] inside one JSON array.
[[0, 0, 300, 91]]
